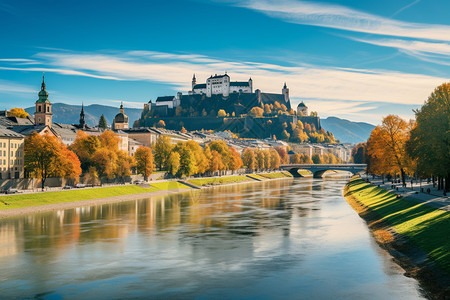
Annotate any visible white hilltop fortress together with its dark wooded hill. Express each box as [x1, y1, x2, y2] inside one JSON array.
[[133, 73, 321, 138]]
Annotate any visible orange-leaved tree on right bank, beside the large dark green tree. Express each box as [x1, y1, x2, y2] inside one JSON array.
[[367, 115, 413, 185]]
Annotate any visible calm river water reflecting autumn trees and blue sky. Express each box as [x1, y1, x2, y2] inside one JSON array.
[[0, 178, 422, 299]]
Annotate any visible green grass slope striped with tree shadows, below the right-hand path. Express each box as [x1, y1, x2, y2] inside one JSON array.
[[346, 177, 450, 274]]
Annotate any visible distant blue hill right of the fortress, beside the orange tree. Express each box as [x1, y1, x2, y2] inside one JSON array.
[[320, 117, 375, 144]]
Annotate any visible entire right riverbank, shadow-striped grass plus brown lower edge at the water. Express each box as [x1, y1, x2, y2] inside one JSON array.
[[344, 176, 450, 299]]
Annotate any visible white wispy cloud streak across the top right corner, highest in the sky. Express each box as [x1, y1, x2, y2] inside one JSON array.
[[230, 0, 450, 41]]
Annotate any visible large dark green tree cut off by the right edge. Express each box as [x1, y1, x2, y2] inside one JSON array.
[[407, 83, 450, 191]]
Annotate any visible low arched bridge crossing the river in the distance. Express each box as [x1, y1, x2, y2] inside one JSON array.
[[280, 164, 367, 178]]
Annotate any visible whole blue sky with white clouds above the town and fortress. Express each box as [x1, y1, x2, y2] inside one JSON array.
[[0, 0, 450, 124]]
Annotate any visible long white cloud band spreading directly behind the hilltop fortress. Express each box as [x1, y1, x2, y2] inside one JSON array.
[[0, 51, 447, 108]]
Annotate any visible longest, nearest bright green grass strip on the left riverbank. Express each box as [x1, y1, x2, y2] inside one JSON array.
[[0, 181, 190, 209]]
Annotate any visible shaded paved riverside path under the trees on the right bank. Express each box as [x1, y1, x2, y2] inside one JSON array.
[[368, 176, 450, 211]]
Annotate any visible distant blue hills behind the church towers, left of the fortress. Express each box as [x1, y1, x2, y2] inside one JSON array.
[[25, 103, 142, 126]]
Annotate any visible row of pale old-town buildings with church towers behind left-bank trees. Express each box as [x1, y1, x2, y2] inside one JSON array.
[[0, 78, 351, 179]]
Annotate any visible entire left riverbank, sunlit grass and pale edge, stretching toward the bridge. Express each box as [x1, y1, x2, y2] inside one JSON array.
[[0, 172, 289, 219]]
